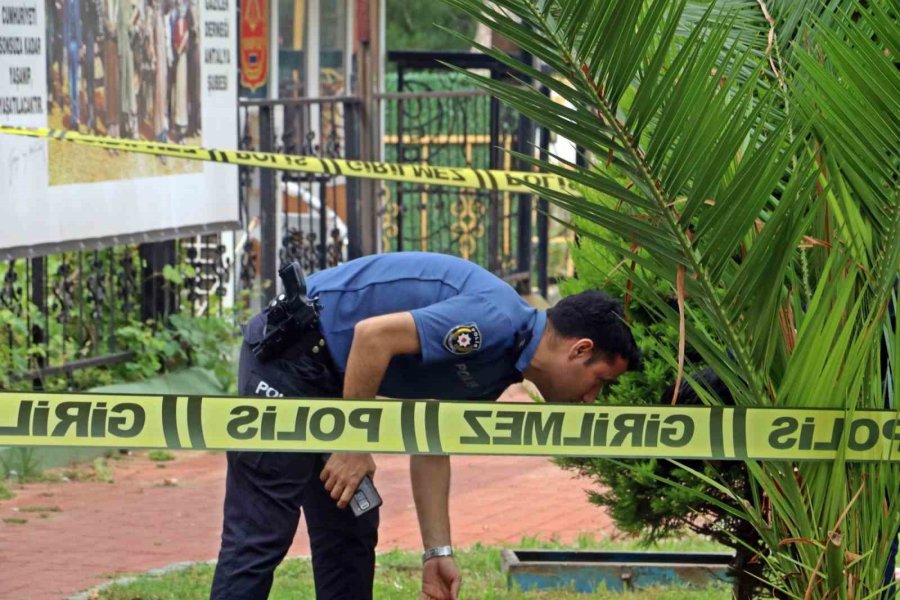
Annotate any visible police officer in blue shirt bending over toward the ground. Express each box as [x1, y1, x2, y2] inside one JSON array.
[[212, 253, 640, 600]]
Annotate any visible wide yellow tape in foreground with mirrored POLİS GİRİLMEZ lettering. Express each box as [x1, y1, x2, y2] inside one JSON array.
[[0, 392, 900, 462]]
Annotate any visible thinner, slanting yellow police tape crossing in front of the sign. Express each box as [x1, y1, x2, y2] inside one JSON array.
[[0, 125, 574, 193]]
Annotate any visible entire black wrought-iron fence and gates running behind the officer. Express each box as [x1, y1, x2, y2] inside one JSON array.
[[0, 53, 568, 388]]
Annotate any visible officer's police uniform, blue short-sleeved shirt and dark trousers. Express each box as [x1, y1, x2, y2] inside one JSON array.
[[212, 252, 547, 600]]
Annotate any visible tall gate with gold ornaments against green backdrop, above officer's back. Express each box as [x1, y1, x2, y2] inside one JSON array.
[[380, 71, 530, 271]]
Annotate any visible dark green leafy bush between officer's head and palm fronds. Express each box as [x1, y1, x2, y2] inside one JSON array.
[[556, 218, 761, 594]]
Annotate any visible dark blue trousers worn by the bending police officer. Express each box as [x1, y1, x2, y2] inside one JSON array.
[[210, 343, 378, 600]]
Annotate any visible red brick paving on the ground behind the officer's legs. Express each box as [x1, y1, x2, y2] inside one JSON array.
[[0, 452, 613, 600]]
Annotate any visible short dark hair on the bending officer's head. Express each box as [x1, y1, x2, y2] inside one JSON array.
[[547, 290, 641, 371]]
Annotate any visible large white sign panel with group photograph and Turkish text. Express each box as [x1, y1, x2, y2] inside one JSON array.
[[0, 0, 238, 256]]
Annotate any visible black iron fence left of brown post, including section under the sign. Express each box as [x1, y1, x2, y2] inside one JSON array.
[[0, 98, 362, 389]]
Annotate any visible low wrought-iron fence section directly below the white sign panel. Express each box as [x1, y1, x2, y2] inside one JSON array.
[[0, 234, 231, 388]]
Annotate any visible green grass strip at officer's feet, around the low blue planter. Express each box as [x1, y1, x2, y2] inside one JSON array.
[[96, 536, 731, 600]]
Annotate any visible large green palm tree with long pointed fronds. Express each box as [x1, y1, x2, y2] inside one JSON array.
[[446, 0, 900, 598]]
